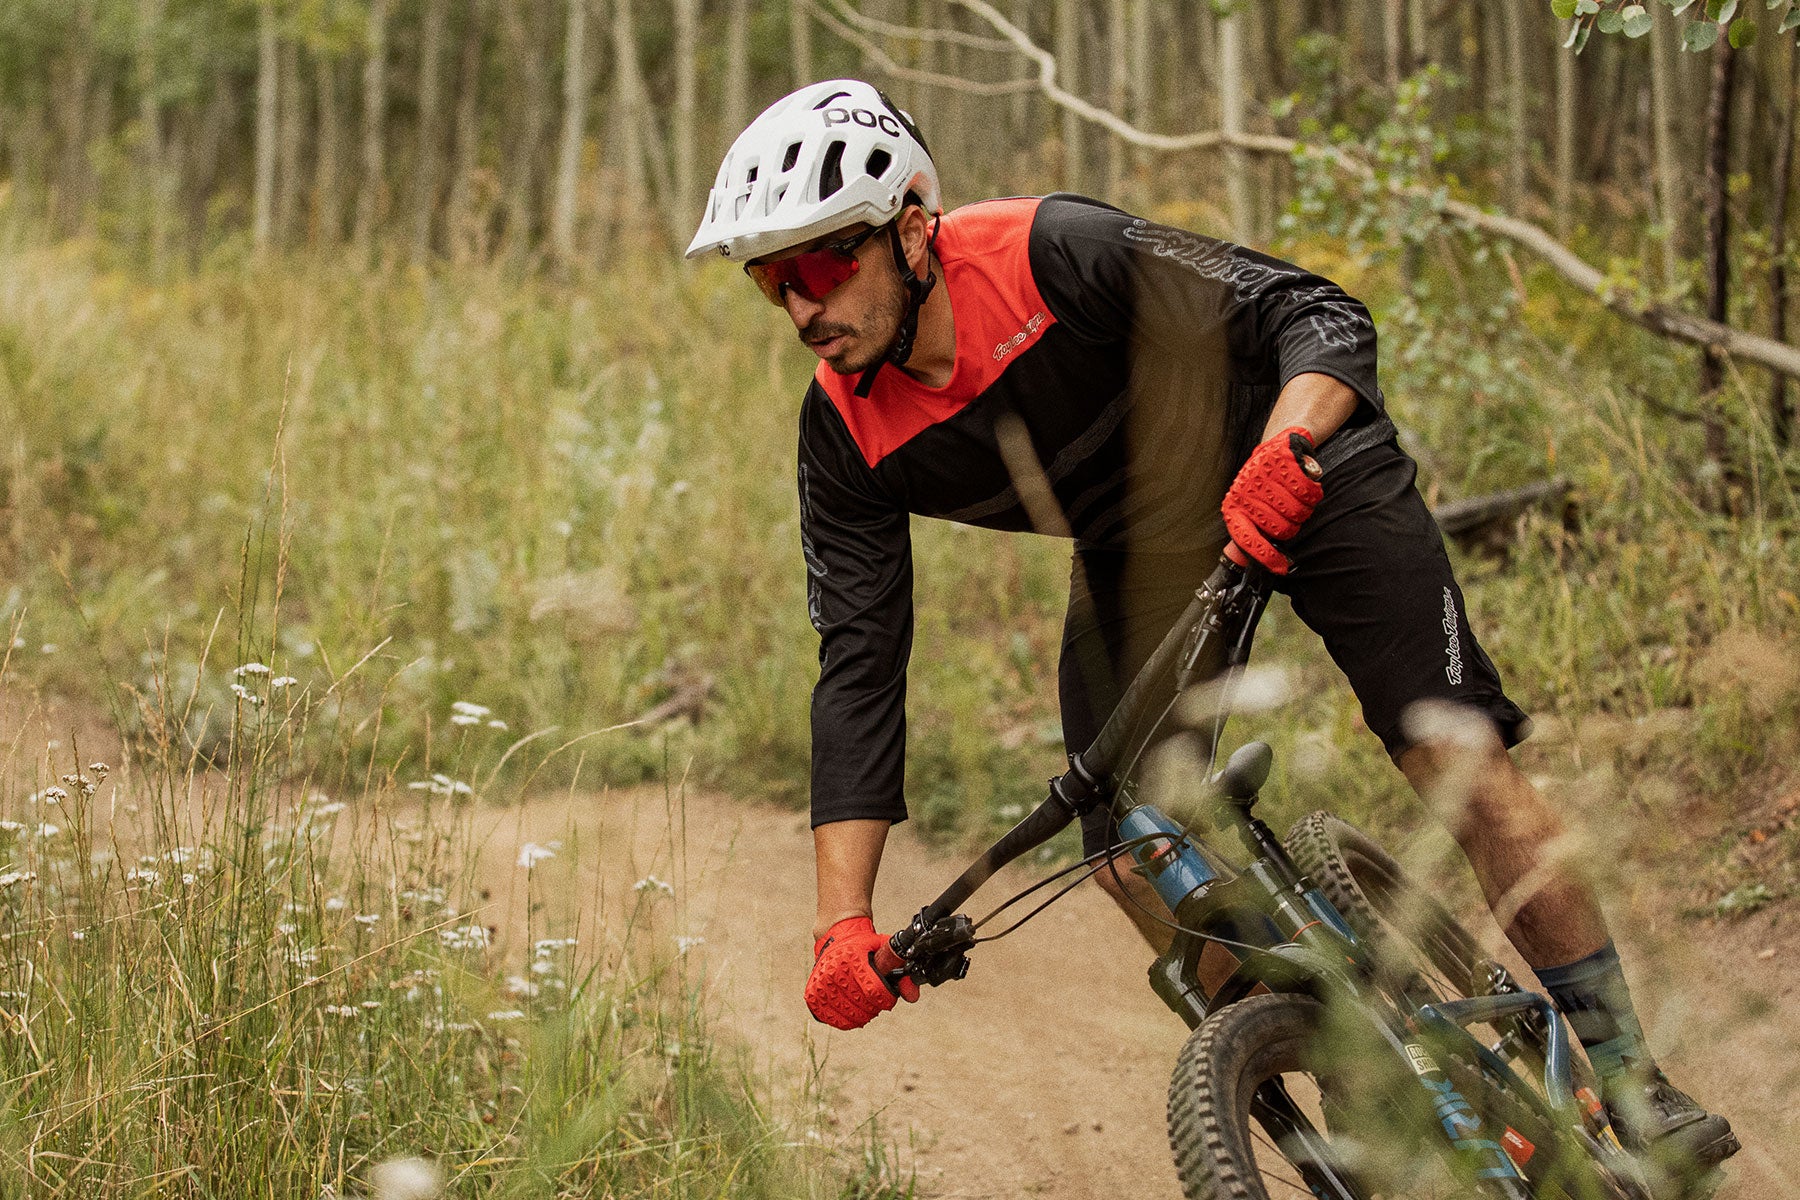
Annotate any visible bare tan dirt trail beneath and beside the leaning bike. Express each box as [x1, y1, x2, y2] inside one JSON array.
[[488, 792, 1800, 1200]]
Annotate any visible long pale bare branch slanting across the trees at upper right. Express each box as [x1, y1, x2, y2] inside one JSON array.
[[814, 0, 1800, 380]]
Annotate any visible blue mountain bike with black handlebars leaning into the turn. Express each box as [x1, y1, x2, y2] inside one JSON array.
[[875, 558, 1694, 1200]]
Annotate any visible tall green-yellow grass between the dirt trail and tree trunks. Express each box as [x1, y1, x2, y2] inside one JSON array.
[[0, 197, 1800, 935]]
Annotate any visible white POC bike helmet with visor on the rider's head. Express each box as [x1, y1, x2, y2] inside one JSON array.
[[688, 79, 941, 263]]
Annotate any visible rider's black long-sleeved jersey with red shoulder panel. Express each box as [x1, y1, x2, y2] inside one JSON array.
[[799, 194, 1393, 826]]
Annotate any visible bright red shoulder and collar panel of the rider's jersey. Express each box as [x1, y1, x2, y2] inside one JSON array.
[[814, 196, 1057, 468]]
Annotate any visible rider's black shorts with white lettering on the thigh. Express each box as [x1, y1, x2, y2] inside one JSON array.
[[1058, 441, 1530, 853]]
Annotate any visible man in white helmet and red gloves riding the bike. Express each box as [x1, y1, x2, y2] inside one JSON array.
[[688, 79, 1737, 1166]]
